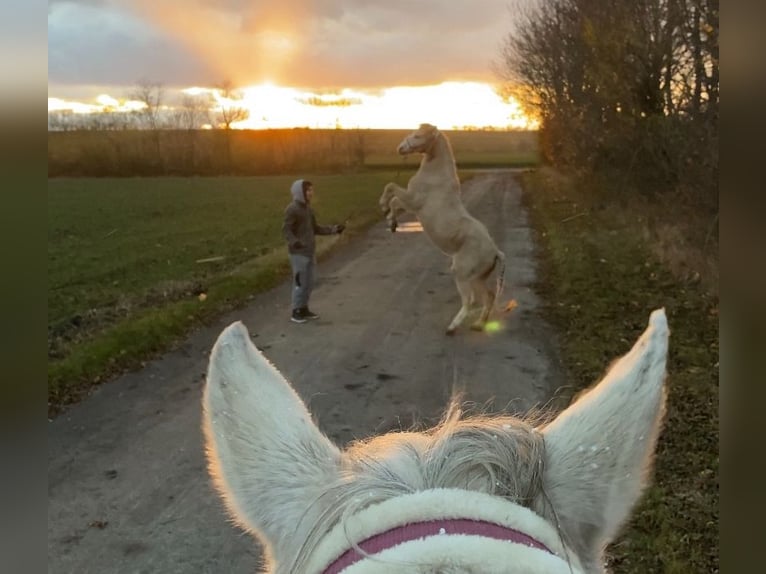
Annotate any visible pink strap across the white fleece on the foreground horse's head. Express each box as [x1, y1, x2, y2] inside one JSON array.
[[323, 518, 553, 574]]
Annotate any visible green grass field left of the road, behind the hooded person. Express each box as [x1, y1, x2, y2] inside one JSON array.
[[48, 172, 417, 416]]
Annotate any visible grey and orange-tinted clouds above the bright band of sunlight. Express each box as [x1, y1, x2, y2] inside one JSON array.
[[48, 0, 512, 88]]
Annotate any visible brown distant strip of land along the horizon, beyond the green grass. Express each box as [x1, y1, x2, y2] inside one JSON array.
[[48, 126, 539, 177]]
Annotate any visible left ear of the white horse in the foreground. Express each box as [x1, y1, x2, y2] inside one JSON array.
[[203, 322, 340, 559]]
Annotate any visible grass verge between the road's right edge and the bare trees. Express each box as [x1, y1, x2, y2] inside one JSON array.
[[522, 170, 719, 574]]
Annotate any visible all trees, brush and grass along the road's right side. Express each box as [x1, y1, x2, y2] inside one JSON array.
[[503, 7, 720, 574]]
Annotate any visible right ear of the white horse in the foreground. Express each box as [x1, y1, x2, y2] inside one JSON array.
[[543, 309, 669, 557]]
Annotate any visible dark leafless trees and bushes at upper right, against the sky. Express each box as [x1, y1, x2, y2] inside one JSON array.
[[496, 0, 719, 213]]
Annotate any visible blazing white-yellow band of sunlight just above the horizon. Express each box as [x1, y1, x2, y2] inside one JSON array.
[[48, 82, 538, 129]]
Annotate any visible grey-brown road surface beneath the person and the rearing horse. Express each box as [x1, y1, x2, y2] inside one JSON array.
[[48, 172, 563, 574]]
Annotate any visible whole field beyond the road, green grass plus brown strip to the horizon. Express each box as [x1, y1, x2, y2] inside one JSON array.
[[48, 126, 538, 413]]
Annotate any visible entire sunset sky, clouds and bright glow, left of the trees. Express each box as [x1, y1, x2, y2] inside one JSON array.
[[48, 0, 523, 128]]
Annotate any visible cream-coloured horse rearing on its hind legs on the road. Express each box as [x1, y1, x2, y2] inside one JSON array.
[[380, 124, 505, 335]]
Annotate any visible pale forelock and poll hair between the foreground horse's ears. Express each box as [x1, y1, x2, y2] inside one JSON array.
[[289, 404, 545, 571]]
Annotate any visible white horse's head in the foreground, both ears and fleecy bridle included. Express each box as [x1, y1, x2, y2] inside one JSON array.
[[203, 310, 668, 574]]
